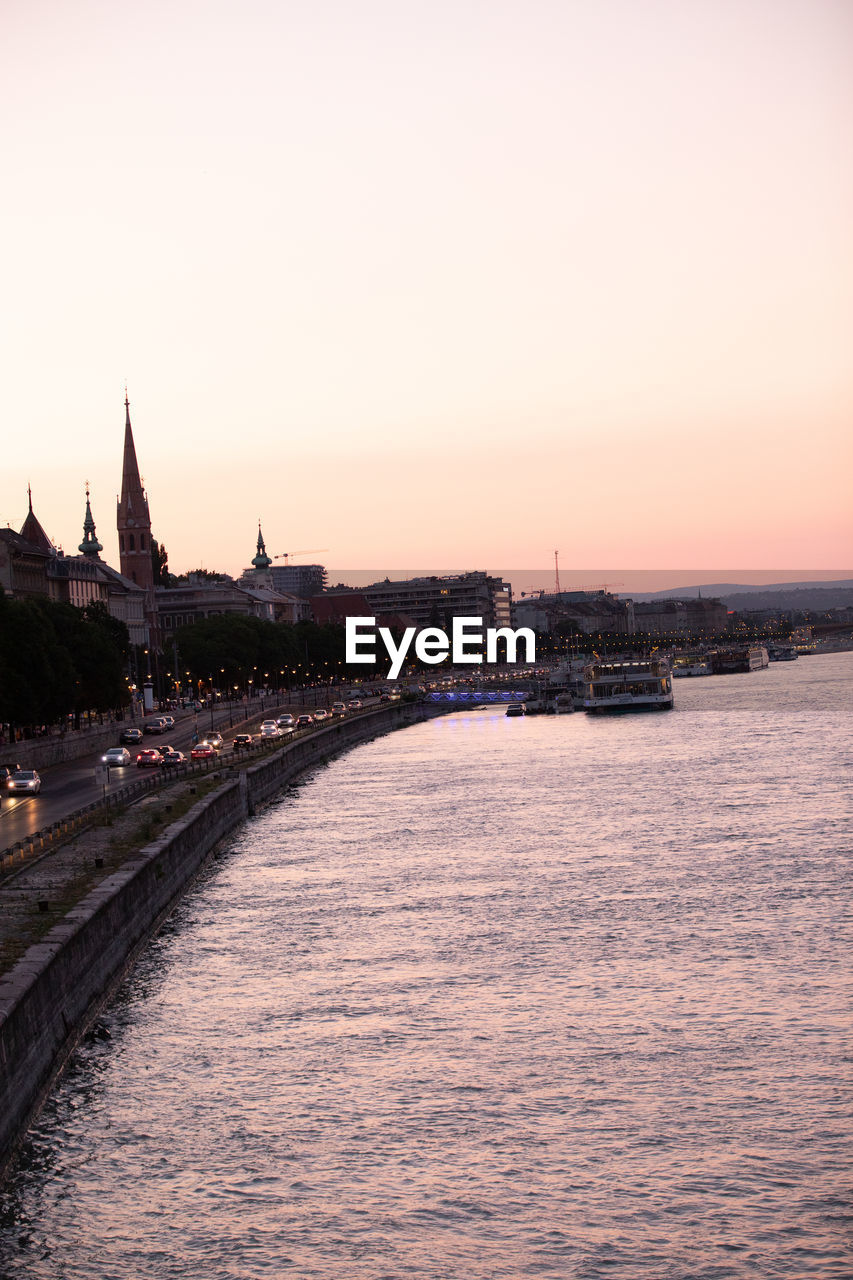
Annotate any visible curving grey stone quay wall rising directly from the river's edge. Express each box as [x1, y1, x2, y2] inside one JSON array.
[[0, 703, 425, 1174]]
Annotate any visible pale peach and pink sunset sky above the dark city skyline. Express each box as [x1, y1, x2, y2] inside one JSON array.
[[0, 0, 853, 586]]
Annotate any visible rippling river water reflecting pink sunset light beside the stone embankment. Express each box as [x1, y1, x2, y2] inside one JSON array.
[[0, 654, 853, 1280]]
